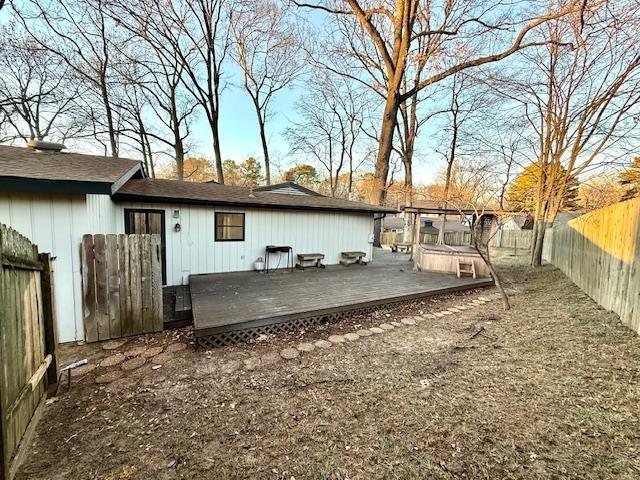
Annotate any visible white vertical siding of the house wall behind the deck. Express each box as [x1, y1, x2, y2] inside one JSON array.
[[87, 195, 373, 285]]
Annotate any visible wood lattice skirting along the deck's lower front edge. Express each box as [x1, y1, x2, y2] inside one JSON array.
[[196, 299, 420, 349]]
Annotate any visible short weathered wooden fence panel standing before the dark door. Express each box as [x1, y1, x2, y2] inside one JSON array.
[[82, 235, 163, 342]]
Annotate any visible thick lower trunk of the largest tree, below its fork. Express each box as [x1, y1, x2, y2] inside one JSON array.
[[370, 88, 400, 205]]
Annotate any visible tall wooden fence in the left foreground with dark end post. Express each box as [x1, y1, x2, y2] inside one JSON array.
[[0, 225, 57, 479]]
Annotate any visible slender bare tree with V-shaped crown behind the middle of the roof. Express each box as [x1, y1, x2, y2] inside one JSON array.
[[232, 0, 305, 185]]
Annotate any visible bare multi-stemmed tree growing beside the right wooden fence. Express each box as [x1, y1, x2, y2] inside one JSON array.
[[497, 2, 640, 266]]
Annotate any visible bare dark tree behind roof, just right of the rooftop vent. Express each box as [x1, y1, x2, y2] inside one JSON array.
[[12, 0, 119, 157]]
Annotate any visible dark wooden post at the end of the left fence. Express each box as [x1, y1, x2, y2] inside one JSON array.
[[39, 253, 58, 392]]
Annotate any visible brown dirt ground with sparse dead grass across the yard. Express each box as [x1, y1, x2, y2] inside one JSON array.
[[17, 259, 640, 480]]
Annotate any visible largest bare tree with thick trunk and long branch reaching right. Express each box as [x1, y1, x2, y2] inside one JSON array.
[[293, 0, 586, 204]]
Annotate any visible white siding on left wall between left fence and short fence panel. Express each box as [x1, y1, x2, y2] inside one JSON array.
[[0, 192, 87, 342]]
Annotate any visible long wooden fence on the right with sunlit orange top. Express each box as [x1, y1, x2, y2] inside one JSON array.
[[543, 198, 640, 333]]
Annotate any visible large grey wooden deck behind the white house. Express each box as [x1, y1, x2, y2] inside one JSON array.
[[189, 249, 493, 344]]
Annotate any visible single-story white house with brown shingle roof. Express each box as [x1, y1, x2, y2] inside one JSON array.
[[0, 144, 390, 342]]
